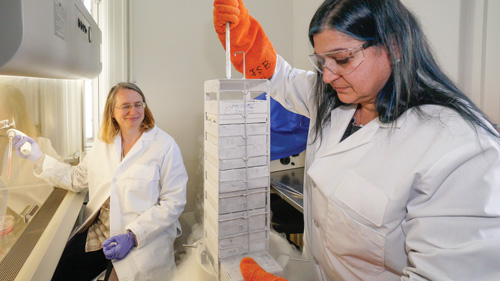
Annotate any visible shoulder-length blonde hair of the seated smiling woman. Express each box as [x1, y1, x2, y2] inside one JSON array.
[[99, 82, 155, 143]]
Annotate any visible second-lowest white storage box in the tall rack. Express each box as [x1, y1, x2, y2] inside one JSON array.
[[204, 200, 269, 238]]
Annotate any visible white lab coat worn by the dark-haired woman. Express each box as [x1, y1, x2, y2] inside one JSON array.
[[270, 56, 500, 280]]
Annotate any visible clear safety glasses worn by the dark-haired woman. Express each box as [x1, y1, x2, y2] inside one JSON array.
[[309, 42, 373, 76]]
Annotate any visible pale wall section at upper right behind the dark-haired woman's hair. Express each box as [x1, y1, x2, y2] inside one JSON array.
[[402, 0, 500, 124]]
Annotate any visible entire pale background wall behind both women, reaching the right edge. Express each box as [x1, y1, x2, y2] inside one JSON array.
[[100, 0, 500, 241]]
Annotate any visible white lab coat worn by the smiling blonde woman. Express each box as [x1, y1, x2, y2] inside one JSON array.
[[37, 126, 188, 281]]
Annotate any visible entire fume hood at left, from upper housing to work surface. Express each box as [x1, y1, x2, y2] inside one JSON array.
[[0, 0, 102, 280]]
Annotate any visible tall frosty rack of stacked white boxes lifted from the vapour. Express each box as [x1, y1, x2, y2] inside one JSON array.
[[204, 79, 283, 281]]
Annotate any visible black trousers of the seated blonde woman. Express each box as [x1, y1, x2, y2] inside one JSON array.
[[52, 230, 108, 281]]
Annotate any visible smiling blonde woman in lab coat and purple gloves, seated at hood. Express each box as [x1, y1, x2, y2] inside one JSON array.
[[15, 83, 188, 280]]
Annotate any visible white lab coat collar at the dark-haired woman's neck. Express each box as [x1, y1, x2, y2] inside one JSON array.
[[318, 104, 406, 157]]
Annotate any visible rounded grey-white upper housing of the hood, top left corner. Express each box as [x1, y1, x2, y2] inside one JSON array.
[[0, 0, 102, 79]]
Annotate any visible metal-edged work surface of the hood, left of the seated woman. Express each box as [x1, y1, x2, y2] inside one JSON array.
[[0, 185, 86, 281]]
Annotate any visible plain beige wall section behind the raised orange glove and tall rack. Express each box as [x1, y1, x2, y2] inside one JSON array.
[[129, 0, 294, 221]]
